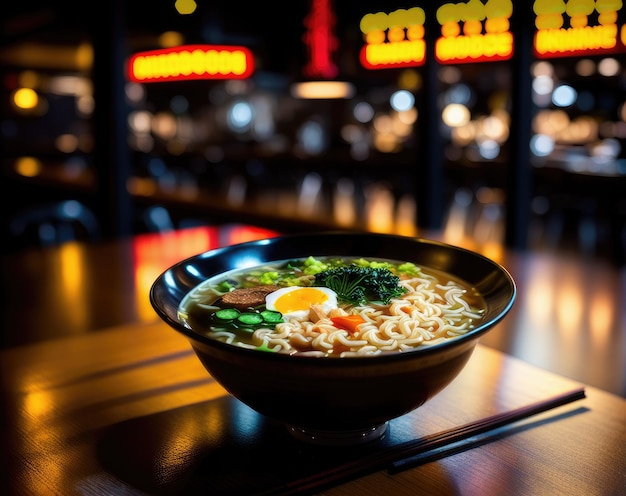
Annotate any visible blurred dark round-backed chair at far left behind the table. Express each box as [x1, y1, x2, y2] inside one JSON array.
[[5, 200, 101, 250]]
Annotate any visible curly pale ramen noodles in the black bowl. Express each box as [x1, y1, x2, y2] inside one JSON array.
[[181, 260, 484, 357]]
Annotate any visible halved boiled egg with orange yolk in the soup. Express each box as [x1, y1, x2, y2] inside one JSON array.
[[265, 286, 337, 318]]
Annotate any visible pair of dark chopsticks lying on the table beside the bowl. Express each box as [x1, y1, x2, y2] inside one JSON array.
[[255, 388, 585, 496]]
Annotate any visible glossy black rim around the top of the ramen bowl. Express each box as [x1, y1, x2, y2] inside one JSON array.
[[149, 231, 517, 366]]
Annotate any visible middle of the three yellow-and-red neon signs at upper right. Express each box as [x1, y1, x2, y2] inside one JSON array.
[[435, 0, 513, 64]]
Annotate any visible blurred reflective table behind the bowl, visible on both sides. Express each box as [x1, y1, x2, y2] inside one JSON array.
[[0, 224, 626, 397]]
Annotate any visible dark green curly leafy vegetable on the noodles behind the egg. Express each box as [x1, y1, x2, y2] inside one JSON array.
[[314, 264, 406, 305]]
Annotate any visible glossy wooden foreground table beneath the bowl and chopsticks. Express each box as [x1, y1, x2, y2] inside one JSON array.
[[0, 322, 626, 496]]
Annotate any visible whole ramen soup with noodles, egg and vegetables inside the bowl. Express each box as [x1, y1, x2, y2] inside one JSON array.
[[178, 256, 486, 357]]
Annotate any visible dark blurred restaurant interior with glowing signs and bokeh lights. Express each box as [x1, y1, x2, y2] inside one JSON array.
[[0, 0, 626, 266]]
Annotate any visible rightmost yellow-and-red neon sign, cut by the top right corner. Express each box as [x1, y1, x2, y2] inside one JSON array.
[[533, 0, 626, 58]]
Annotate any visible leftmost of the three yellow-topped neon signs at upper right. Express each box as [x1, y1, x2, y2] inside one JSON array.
[[359, 7, 426, 69]]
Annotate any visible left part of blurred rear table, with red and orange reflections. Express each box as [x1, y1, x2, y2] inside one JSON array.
[[0, 224, 277, 348]]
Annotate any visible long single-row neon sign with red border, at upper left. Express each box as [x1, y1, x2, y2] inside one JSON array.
[[127, 45, 254, 83]]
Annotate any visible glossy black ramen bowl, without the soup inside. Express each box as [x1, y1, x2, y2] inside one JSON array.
[[150, 232, 516, 445]]
